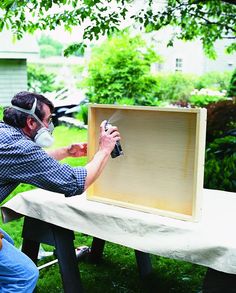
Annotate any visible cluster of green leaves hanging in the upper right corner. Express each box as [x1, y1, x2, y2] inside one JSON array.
[[141, 0, 236, 58]]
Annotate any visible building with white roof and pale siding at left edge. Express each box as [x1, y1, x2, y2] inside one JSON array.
[[0, 31, 39, 106]]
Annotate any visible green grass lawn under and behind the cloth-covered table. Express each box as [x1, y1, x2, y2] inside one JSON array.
[[1, 126, 206, 293]]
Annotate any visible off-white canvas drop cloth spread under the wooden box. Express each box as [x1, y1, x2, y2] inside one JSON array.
[[2, 189, 236, 274]]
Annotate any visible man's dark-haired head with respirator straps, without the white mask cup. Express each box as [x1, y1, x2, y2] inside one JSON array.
[[3, 92, 54, 145]]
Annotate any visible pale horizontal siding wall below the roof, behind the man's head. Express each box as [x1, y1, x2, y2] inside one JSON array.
[[0, 59, 27, 106]]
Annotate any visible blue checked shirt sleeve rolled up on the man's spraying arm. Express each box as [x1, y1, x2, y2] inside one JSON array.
[[6, 140, 87, 196]]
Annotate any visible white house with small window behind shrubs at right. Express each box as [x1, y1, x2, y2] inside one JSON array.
[[148, 27, 236, 75]]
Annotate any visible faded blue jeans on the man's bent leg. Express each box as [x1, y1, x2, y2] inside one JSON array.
[[0, 229, 39, 293]]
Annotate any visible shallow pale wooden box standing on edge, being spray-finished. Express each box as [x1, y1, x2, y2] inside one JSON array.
[[87, 105, 206, 221]]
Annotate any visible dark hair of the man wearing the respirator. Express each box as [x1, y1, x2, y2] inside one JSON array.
[[3, 92, 54, 128]]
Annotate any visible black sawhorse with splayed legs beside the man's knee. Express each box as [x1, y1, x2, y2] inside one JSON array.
[[22, 217, 83, 293]]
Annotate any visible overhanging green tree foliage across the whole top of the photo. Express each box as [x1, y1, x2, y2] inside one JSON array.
[[0, 0, 236, 56]]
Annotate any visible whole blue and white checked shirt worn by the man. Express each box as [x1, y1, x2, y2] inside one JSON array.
[[0, 122, 87, 202]]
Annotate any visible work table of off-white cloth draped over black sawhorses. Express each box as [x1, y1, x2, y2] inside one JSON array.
[[1, 189, 236, 292]]
